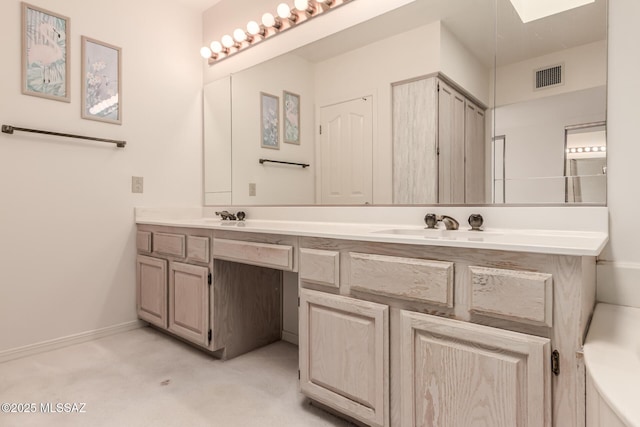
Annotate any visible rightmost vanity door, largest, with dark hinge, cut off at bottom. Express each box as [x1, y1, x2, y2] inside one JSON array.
[[400, 311, 551, 427]]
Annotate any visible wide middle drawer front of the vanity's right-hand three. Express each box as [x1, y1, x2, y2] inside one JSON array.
[[349, 252, 453, 307]]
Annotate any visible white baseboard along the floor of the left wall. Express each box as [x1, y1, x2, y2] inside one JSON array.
[[0, 320, 146, 363]]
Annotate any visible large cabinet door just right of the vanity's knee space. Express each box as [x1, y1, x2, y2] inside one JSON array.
[[300, 289, 389, 426]]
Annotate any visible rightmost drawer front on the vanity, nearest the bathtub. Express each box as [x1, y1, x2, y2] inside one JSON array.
[[469, 266, 553, 327]]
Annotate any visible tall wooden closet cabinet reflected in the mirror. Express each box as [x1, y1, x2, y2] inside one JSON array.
[[392, 76, 487, 204]]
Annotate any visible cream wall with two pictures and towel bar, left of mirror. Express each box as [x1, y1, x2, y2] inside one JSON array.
[[0, 0, 202, 354]]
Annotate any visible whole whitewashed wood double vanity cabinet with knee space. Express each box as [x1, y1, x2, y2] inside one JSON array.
[[137, 222, 595, 427]]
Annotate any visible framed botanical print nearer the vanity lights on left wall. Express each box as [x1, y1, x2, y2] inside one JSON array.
[[82, 36, 122, 124]]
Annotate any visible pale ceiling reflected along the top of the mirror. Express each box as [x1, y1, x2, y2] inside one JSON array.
[[296, 0, 607, 67]]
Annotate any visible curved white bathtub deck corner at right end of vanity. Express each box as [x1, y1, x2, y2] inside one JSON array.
[[584, 303, 640, 426]]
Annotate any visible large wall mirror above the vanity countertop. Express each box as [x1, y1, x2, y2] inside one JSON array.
[[204, 0, 607, 205]]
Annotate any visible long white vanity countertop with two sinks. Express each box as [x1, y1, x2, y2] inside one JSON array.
[[136, 215, 608, 256]]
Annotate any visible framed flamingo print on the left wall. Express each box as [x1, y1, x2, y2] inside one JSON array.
[[22, 2, 71, 102]]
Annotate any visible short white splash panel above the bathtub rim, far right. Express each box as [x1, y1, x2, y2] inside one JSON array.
[[596, 261, 640, 308]]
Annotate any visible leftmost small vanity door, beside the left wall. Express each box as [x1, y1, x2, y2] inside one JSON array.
[[136, 255, 167, 328]]
